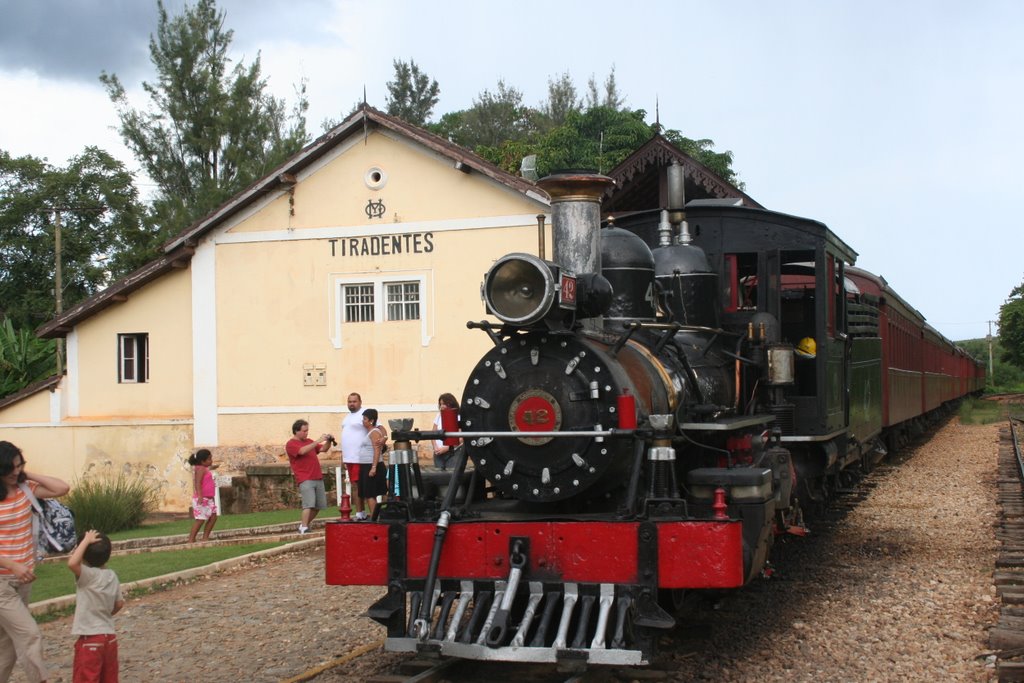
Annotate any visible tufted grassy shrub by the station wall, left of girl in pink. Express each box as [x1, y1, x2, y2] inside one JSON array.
[[65, 474, 160, 533]]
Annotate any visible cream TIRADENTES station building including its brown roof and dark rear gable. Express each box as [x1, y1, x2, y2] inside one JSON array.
[[0, 104, 757, 510]]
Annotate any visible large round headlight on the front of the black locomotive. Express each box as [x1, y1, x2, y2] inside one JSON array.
[[483, 254, 563, 326]]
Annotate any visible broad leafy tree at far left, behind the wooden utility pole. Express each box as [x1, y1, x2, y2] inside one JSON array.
[[0, 147, 149, 329]]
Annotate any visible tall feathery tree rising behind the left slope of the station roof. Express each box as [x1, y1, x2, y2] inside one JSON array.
[[100, 0, 308, 236]]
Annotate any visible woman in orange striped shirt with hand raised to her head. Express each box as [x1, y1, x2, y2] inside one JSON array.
[[0, 441, 69, 683]]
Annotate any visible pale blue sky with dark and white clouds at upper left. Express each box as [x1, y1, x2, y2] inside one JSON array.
[[0, 0, 1024, 340]]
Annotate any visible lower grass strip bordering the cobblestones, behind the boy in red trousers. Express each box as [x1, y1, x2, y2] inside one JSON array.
[[32, 542, 284, 602]]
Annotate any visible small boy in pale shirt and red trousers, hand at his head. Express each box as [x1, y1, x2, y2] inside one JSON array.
[[68, 529, 125, 683]]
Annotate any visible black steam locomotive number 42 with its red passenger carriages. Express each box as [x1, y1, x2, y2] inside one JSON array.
[[327, 165, 984, 665]]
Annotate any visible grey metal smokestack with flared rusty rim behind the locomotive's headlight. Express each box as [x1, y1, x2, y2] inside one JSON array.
[[537, 173, 615, 284]]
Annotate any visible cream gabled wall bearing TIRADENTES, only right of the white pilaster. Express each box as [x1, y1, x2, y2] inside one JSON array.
[[216, 133, 545, 445]]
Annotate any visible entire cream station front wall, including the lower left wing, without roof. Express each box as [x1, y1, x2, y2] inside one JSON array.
[[0, 122, 546, 510]]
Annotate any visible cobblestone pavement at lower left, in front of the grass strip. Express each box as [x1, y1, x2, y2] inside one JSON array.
[[11, 547, 383, 683]]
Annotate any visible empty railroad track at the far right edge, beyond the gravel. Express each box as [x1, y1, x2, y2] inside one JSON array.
[[989, 418, 1024, 681]]
